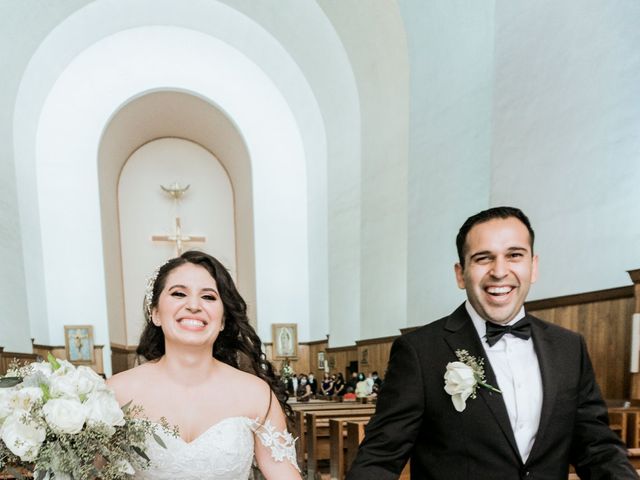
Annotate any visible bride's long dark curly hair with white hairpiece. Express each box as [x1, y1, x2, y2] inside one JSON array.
[[136, 250, 293, 421]]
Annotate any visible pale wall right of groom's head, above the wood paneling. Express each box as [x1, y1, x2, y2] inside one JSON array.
[[491, 0, 640, 298]]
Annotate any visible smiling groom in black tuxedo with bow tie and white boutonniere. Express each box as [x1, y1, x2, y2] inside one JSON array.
[[347, 207, 638, 480]]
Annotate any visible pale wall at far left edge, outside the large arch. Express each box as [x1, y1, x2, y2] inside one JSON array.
[[0, 0, 92, 352]]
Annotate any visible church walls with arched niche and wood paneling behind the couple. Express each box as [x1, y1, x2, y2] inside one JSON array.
[[0, 0, 640, 476]]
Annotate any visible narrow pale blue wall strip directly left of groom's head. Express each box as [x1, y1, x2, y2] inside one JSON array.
[[398, 0, 494, 327]]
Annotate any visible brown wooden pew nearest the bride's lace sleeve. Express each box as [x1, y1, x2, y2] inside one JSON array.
[[301, 407, 375, 479]]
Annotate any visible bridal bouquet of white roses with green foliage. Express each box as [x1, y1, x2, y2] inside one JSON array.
[[0, 355, 168, 480]]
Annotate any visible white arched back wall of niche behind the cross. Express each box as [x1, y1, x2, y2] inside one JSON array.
[[118, 138, 237, 345]]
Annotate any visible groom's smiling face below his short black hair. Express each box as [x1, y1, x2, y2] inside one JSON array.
[[455, 217, 538, 323]]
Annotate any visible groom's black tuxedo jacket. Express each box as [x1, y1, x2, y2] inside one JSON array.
[[347, 304, 638, 480]]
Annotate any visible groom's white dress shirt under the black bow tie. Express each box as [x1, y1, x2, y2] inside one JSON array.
[[465, 300, 542, 462]]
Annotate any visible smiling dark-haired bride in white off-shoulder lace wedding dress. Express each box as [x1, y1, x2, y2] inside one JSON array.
[[108, 251, 301, 480]]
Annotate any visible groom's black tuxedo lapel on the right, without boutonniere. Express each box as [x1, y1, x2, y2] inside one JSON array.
[[529, 317, 562, 459]]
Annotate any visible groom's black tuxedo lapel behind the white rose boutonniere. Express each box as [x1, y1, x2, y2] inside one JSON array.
[[444, 304, 520, 458]]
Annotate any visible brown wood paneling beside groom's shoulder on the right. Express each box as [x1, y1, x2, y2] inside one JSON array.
[[528, 297, 635, 398]]
